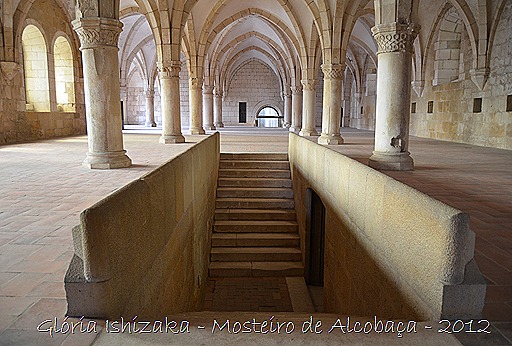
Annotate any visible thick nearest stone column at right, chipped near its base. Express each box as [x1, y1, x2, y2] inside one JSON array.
[[369, 23, 417, 171]]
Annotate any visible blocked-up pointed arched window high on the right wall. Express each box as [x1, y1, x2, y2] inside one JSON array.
[[432, 7, 464, 86]]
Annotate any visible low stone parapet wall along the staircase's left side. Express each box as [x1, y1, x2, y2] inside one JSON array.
[[65, 133, 220, 319]]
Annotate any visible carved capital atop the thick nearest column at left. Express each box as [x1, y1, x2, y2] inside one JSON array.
[[72, 18, 123, 50]]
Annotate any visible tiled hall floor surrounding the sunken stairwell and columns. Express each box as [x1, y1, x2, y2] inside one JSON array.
[[0, 128, 512, 345]]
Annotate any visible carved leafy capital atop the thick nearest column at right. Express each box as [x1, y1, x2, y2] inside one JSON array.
[[372, 23, 419, 54]]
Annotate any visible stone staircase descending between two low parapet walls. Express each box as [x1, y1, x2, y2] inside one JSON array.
[[209, 153, 303, 277]]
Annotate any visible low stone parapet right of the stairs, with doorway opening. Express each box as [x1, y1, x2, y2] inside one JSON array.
[[289, 134, 485, 320]]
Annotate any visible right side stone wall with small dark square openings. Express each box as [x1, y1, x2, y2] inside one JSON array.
[[410, 2, 512, 149]]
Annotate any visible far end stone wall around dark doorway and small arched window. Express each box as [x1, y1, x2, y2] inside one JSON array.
[[222, 61, 284, 126]]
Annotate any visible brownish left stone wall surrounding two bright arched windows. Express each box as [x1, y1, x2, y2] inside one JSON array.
[[0, 0, 86, 144]]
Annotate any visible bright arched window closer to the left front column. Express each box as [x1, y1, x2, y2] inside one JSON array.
[[53, 36, 75, 112]]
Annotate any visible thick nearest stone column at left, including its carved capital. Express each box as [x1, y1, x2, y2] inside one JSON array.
[[73, 17, 132, 169]]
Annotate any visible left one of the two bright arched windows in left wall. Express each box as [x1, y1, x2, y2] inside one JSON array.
[[21, 25, 50, 112]]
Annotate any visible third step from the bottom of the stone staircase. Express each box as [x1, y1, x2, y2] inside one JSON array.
[[212, 233, 300, 247]]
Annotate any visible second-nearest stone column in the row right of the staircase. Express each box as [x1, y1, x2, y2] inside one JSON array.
[[318, 64, 345, 145]]
